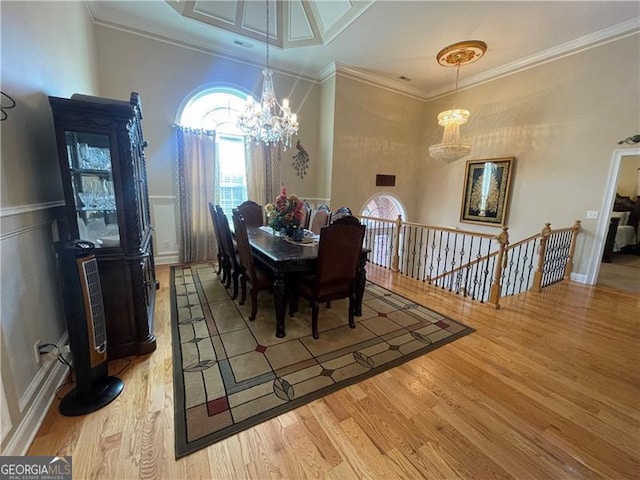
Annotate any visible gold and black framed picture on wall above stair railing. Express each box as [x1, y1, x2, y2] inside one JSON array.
[[460, 157, 515, 227]]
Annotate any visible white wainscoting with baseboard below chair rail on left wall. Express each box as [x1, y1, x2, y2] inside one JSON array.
[[0, 202, 66, 455]]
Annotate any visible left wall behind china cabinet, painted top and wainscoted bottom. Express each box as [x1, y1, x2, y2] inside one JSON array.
[[0, 2, 98, 453]]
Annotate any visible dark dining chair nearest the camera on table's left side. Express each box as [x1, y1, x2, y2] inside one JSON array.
[[233, 208, 273, 321]]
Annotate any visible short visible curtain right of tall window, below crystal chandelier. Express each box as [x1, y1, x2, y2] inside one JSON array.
[[245, 139, 282, 205]]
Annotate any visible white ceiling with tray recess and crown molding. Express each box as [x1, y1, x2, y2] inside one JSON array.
[[87, 0, 640, 98]]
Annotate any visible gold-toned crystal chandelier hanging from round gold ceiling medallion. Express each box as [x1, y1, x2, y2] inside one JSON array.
[[429, 40, 487, 163]]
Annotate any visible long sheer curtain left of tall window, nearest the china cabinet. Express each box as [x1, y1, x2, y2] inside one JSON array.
[[176, 126, 217, 263]]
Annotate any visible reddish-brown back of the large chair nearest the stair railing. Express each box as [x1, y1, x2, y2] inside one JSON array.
[[314, 216, 365, 297]]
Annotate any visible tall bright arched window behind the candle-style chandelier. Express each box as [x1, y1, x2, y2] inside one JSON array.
[[178, 88, 252, 218]]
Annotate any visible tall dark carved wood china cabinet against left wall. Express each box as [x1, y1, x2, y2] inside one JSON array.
[[49, 92, 157, 358]]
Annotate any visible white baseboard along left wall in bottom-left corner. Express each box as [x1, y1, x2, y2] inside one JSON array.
[[2, 361, 69, 456]]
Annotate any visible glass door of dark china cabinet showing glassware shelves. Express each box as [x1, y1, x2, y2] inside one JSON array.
[[65, 131, 120, 248]]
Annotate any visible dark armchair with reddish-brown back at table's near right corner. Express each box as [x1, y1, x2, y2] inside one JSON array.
[[290, 215, 365, 339]]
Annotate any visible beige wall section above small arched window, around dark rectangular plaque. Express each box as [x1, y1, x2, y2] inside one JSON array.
[[331, 73, 426, 221]]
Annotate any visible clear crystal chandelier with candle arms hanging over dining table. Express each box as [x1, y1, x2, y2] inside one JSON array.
[[238, 0, 298, 150]]
